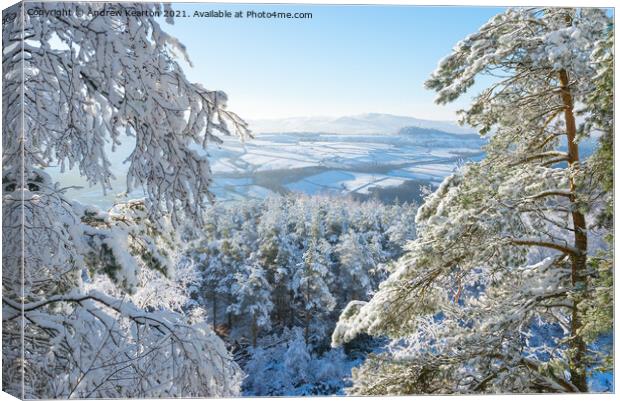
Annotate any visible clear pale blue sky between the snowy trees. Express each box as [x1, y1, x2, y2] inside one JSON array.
[[156, 4, 503, 120]]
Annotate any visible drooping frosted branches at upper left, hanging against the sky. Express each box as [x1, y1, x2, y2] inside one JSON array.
[[3, 3, 249, 223]]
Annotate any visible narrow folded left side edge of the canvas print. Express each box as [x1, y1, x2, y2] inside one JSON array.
[[2, 3, 25, 398]]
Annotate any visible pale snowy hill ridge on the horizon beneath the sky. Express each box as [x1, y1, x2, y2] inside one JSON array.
[[248, 113, 475, 135]]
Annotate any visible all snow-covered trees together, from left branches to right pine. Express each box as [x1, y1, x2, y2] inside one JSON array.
[[2, 2, 614, 399]]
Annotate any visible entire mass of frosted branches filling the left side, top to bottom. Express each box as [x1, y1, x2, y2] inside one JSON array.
[[2, 2, 249, 398]]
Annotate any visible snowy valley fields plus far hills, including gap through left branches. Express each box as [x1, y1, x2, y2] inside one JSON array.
[[50, 114, 484, 207]]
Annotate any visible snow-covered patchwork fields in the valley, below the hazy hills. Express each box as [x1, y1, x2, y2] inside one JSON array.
[[210, 123, 484, 200]]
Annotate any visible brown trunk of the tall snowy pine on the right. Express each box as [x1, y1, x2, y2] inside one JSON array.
[[559, 70, 588, 391]]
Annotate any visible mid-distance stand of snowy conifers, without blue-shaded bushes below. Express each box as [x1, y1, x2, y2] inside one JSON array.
[[188, 195, 417, 349]]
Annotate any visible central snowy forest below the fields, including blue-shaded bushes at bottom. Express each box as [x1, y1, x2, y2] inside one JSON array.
[[186, 194, 417, 396]]
